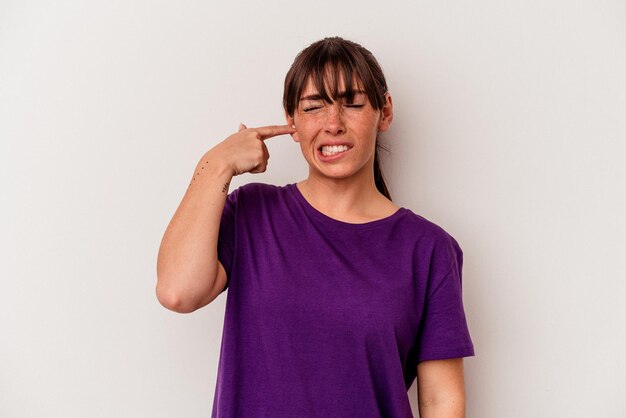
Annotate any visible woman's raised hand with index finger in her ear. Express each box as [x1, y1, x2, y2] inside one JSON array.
[[210, 123, 296, 176]]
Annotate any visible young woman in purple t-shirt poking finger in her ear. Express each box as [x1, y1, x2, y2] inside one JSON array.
[[157, 38, 474, 418]]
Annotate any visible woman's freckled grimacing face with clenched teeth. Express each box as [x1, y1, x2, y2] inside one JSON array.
[[287, 75, 393, 183]]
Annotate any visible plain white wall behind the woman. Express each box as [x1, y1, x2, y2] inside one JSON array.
[[0, 0, 626, 418]]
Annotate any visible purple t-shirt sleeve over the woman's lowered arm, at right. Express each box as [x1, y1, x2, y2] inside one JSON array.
[[417, 245, 474, 362]]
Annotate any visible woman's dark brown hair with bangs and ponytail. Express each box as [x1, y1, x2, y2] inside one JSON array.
[[283, 37, 391, 200]]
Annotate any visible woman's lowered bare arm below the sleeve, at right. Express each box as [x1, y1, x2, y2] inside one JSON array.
[[417, 358, 465, 418]]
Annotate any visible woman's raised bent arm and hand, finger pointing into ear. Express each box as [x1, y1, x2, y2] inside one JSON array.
[[156, 125, 295, 313]]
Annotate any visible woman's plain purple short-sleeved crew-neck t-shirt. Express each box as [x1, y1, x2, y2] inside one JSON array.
[[213, 183, 474, 418]]
